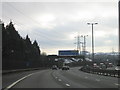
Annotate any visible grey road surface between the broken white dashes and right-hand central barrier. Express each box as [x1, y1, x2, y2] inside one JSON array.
[[52, 68, 118, 88]]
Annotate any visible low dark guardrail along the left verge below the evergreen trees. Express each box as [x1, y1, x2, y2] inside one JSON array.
[[2, 67, 48, 74]]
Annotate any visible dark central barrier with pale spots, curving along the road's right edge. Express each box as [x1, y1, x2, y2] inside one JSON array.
[[80, 67, 120, 78]]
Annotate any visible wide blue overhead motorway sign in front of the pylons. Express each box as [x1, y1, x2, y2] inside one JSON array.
[[58, 50, 79, 56]]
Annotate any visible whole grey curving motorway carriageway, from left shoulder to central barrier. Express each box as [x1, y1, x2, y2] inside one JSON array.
[[3, 67, 119, 88]]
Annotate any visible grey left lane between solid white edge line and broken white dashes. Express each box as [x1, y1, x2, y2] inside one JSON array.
[[13, 70, 65, 88]]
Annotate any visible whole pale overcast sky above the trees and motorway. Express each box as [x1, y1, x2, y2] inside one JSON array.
[[1, 0, 118, 54]]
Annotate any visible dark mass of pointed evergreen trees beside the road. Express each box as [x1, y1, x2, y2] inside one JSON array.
[[2, 22, 41, 69]]
